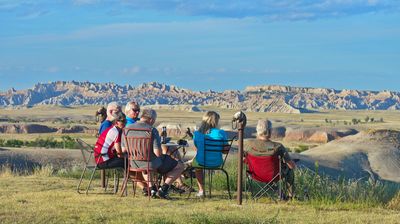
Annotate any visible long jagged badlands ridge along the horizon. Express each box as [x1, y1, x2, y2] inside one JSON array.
[[0, 81, 400, 113]]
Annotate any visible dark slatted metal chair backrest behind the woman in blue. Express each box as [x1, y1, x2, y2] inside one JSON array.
[[201, 137, 235, 167]]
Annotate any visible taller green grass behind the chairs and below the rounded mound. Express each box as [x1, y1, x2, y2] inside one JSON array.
[[206, 155, 400, 206]]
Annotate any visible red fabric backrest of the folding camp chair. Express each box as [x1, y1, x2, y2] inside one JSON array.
[[245, 153, 280, 183]]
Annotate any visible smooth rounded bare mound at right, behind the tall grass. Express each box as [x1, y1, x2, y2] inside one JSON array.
[[293, 130, 400, 182]]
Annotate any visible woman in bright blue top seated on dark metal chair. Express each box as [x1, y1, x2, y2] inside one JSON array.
[[192, 111, 227, 197]]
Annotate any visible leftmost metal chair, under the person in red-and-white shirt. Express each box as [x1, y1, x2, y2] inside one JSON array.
[[76, 138, 121, 194]]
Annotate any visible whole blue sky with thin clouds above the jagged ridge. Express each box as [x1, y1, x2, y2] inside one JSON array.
[[0, 0, 400, 91]]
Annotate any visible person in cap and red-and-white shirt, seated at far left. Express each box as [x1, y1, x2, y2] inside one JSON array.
[[94, 111, 126, 169]]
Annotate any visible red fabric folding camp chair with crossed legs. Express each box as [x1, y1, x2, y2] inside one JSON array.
[[244, 152, 282, 201]]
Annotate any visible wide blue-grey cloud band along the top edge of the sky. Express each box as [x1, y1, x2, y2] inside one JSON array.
[[108, 0, 400, 20]]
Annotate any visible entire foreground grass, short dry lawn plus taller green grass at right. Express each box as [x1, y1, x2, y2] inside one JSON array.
[[0, 157, 400, 223]]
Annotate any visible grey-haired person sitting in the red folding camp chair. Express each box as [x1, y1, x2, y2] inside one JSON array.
[[245, 119, 296, 198]]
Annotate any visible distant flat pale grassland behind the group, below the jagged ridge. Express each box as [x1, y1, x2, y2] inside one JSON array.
[[0, 106, 400, 142]]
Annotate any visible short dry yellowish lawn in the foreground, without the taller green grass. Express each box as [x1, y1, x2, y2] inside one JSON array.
[[0, 171, 400, 224]]
